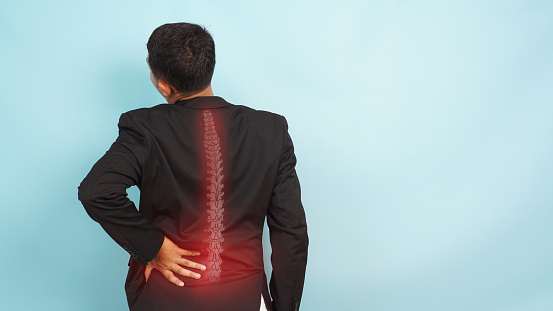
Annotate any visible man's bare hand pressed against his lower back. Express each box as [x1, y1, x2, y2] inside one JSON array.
[[144, 237, 206, 286]]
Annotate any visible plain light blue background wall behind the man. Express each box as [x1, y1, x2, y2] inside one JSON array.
[[0, 0, 553, 311]]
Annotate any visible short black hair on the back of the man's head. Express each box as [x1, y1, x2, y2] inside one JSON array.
[[146, 23, 215, 96]]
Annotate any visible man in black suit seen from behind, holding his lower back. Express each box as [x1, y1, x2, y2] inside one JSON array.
[[78, 23, 308, 311]]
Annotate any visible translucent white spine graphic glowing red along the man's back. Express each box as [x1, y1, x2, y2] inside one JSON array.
[[203, 110, 224, 282]]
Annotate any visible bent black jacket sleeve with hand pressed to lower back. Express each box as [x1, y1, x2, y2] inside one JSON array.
[[78, 113, 164, 265]]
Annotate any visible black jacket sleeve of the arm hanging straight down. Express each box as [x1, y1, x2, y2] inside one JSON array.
[[267, 117, 309, 311]]
